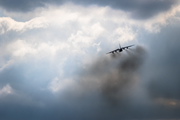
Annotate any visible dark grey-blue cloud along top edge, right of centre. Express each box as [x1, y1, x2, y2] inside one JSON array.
[[72, 0, 177, 19]]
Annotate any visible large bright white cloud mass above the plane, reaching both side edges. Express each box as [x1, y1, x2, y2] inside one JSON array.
[[0, 4, 180, 63]]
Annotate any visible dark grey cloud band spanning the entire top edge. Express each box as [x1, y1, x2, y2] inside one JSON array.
[[0, 0, 178, 19]]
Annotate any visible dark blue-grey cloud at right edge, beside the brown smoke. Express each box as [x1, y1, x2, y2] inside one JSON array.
[[140, 24, 180, 100]]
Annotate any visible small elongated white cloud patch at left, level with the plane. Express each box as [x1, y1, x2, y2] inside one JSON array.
[[6, 40, 68, 58]]
